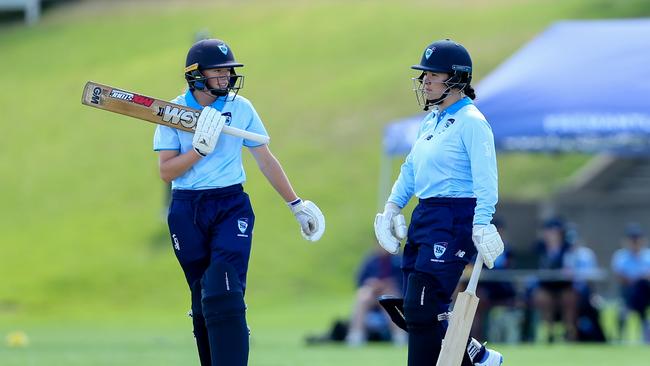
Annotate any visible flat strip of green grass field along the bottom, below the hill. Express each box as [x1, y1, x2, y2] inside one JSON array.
[[0, 324, 650, 366]]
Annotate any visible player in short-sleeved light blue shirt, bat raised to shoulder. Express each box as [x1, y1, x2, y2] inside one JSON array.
[[153, 39, 325, 366]]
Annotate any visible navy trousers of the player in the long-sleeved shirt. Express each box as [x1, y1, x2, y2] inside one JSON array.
[[402, 197, 476, 366]]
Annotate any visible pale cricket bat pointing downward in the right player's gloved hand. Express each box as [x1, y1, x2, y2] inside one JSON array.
[[436, 254, 483, 366]]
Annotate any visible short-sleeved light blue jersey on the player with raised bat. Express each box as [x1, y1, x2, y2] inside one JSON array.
[[153, 90, 268, 190]]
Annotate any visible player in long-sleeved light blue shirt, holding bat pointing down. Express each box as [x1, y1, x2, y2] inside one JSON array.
[[375, 39, 504, 366]]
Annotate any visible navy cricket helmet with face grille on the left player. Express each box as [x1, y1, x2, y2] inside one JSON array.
[[185, 39, 244, 99]]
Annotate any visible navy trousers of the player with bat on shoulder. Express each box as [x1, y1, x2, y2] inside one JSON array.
[[167, 184, 255, 366]]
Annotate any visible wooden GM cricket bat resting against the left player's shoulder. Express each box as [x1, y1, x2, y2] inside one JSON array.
[[81, 81, 269, 144]]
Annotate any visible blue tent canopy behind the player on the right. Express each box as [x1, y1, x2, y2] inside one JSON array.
[[383, 19, 650, 155]]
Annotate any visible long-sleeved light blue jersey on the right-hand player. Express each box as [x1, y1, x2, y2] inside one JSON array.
[[388, 97, 498, 225]]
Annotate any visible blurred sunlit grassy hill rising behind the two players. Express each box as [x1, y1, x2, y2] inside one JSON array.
[[0, 0, 650, 324]]
